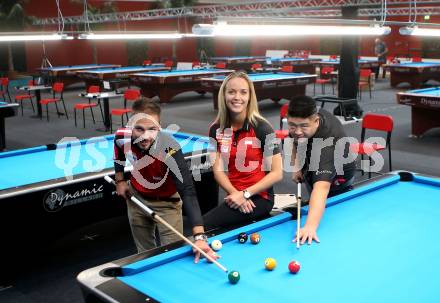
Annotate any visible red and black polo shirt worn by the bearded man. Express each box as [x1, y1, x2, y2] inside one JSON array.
[[114, 128, 203, 226]]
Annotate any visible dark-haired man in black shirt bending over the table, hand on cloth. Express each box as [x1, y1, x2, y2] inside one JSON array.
[[287, 96, 356, 244]]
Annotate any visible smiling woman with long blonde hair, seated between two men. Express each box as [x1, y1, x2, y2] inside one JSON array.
[[203, 72, 283, 228]]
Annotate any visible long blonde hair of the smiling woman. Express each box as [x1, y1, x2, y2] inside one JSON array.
[[214, 71, 267, 129]]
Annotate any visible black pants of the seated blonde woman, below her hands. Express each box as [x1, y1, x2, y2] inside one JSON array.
[[203, 195, 274, 230]]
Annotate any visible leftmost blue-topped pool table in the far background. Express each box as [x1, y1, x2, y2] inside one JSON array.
[[37, 64, 120, 86]]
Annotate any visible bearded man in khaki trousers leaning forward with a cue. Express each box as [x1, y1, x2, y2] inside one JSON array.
[[114, 98, 217, 262]]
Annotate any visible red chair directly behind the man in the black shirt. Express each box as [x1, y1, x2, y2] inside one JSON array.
[[350, 113, 394, 178]]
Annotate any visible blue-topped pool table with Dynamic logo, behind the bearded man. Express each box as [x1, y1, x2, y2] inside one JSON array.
[[0, 133, 218, 276]]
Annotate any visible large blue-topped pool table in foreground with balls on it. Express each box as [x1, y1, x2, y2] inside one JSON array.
[[77, 172, 440, 303]]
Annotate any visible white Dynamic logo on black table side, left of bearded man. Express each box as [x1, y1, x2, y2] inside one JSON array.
[[43, 184, 104, 212]]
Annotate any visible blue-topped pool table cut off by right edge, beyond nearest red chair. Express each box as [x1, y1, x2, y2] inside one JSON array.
[[397, 87, 440, 137]]
